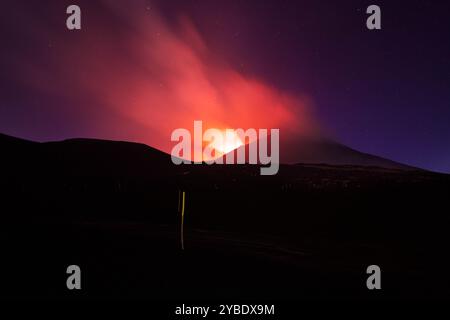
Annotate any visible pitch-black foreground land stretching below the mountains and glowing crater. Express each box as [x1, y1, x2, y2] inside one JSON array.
[[0, 132, 450, 301]]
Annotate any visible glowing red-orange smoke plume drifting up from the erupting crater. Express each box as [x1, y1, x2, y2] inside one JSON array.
[[19, 2, 315, 153]]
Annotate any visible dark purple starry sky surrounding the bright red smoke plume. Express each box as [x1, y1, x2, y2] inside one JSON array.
[[0, 0, 450, 172]]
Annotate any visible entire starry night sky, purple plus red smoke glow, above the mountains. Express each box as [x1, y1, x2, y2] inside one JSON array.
[[0, 0, 450, 172]]
